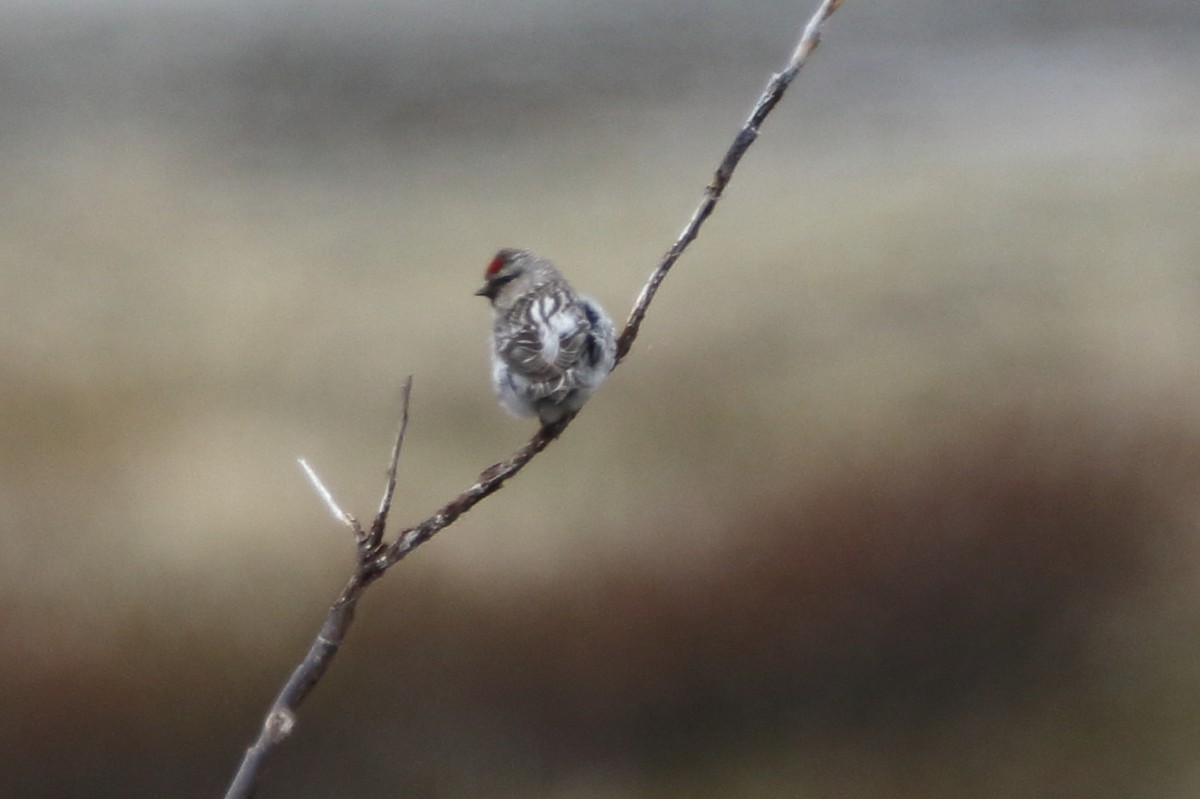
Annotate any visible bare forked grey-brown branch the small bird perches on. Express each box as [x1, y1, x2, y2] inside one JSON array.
[[226, 0, 841, 799]]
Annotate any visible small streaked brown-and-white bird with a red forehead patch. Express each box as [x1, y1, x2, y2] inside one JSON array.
[[475, 250, 617, 425]]
